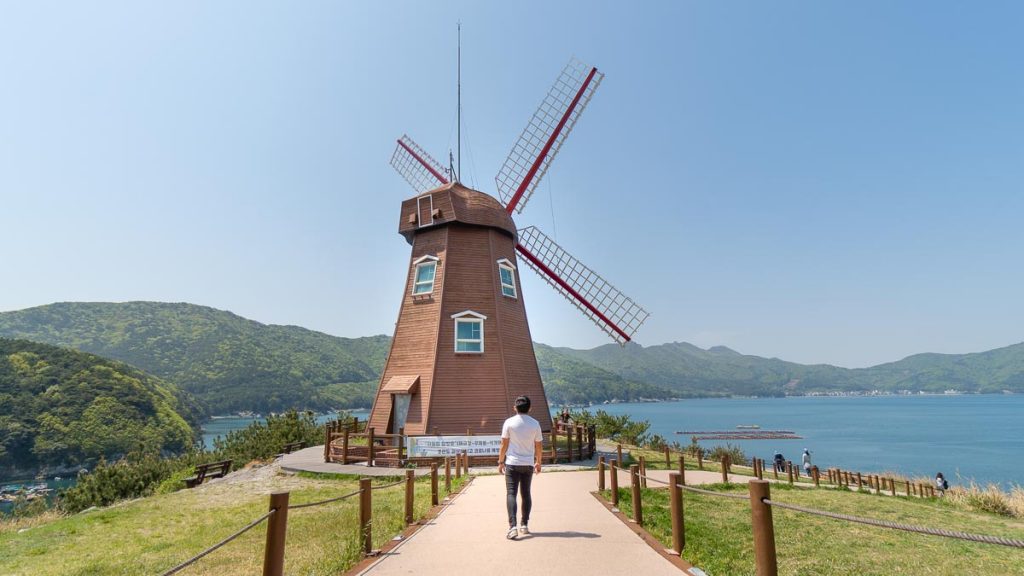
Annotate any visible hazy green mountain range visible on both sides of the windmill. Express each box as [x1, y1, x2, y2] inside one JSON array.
[[0, 302, 1024, 413]]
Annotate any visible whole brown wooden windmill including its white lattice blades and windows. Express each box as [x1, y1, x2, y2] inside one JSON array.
[[369, 59, 647, 436]]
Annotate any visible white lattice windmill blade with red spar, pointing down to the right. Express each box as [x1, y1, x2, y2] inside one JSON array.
[[515, 227, 650, 345]]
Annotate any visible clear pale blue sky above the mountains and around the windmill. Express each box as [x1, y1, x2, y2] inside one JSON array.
[[0, 1, 1024, 367]]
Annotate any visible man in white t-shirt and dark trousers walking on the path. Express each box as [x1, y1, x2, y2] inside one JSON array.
[[498, 396, 544, 540]]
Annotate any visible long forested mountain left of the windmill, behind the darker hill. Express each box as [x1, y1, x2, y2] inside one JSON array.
[[0, 302, 390, 414]]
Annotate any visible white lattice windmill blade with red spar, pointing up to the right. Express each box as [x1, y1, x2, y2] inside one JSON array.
[[495, 58, 604, 214]]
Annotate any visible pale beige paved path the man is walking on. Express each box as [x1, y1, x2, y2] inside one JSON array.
[[360, 470, 745, 576]]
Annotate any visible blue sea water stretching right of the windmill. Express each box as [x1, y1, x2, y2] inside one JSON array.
[[590, 395, 1024, 489]]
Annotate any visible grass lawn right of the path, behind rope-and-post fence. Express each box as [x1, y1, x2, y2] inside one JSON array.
[[603, 479, 1024, 576]]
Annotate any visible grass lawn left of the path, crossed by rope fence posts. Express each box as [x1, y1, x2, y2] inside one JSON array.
[[0, 471, 464, 576]]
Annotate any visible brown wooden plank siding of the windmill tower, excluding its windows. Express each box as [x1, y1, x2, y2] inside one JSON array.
[[369, 184, 552, 435]]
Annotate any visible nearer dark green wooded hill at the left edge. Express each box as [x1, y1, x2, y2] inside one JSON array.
[[0, 338, 203, 474]]
